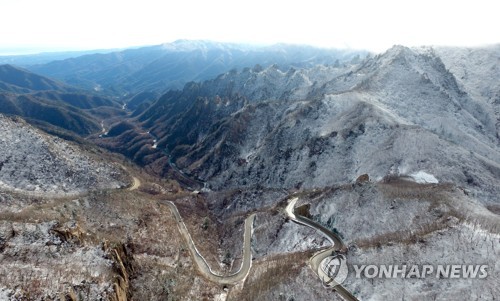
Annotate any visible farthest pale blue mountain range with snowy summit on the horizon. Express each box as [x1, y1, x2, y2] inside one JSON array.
[[27, 40, 366, 96]]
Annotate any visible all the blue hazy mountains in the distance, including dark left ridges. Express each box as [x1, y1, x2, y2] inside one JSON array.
[[0, 40, 366, 135]]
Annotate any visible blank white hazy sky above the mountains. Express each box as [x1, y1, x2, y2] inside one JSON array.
[[0, 0, 500, 53]]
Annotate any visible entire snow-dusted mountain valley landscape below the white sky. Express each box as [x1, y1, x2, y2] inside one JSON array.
[[0, 40, 500, 301]]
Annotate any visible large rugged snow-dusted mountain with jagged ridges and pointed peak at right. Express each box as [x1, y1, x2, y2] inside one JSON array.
[[107, 46, 500, 204]]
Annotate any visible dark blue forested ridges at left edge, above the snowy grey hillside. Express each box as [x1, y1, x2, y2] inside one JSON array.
[[0, 65, 120, 136]]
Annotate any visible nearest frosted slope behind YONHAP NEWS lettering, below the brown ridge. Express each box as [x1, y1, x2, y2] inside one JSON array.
[[345, 220, 500, 300]]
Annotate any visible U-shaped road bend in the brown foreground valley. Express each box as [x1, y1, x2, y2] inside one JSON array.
[[162, 201, 255, 284]]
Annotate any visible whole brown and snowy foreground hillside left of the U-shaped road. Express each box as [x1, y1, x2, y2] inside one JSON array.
[[0, 115, 221, 300]]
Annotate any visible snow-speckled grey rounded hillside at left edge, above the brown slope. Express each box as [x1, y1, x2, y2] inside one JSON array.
[[0, 115, 126, 194]]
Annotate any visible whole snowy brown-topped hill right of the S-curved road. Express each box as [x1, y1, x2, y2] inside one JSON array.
[[301, 182, 500, 300]]
